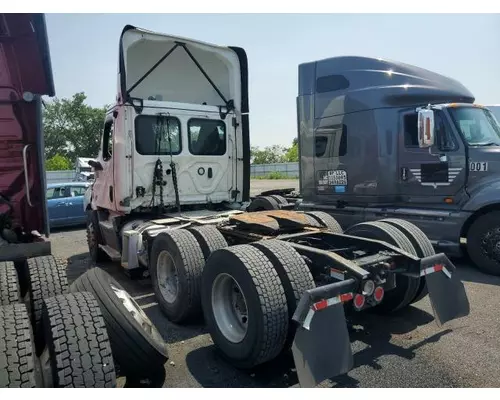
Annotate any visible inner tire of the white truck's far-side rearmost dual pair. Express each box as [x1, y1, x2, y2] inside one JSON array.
[[345, 221, 420, 313]]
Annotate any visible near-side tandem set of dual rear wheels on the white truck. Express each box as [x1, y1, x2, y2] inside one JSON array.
[[150, 223, 315, 368]]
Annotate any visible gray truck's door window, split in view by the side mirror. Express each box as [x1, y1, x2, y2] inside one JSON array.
[[403, 111, 456, 151]]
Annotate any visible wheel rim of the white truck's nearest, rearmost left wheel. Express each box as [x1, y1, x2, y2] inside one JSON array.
[[212, 274, 248, 343]]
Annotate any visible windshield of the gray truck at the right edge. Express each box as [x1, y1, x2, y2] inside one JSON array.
[[449, 107, 500, 146]]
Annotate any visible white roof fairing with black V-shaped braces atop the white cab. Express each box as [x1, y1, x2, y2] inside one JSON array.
[[118, 25, 248, 113]]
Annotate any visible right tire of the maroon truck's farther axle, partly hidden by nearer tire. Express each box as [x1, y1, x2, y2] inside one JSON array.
[[28, 255, 68, 355]]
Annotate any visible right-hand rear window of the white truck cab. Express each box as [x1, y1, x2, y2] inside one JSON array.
[[188, 119, 226, 156]]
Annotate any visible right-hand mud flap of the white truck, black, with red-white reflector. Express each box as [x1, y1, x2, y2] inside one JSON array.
[[420, 254, 470, 326]]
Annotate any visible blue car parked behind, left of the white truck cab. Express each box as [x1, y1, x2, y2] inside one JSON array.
[[47, 182, 90, 228]]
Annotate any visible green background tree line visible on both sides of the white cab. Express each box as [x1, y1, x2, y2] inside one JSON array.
[[43, 92, 298, 171]]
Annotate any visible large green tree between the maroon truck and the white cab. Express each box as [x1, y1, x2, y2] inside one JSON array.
[[43, 92, 106, 160]]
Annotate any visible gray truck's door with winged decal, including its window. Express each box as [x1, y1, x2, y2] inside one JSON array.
[[398, 110, 466, 205]]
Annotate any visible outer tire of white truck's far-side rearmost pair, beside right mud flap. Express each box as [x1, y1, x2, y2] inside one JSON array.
[[381, 218, 436, 304]]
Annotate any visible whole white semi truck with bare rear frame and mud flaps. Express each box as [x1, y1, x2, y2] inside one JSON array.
[[86, 27, 469, 386]]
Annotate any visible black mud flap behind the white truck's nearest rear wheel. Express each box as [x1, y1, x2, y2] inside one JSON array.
[[292, 282, 353, 387]]
